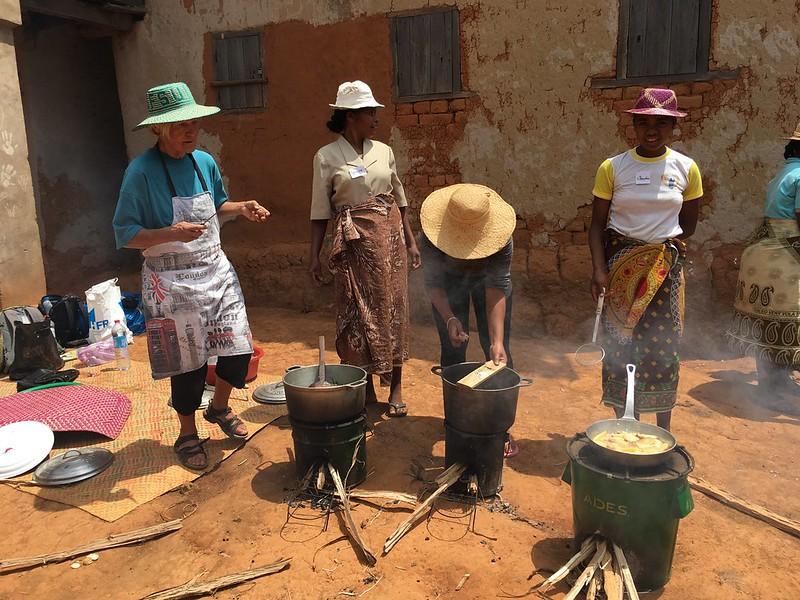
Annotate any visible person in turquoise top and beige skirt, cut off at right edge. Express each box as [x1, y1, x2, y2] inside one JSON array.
[[727, 123, 800, 398]]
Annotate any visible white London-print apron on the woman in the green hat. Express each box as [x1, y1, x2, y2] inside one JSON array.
[[142, 161, 253, 379]]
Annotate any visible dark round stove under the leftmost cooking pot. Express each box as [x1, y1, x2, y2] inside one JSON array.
[[289, 415, 367, 487]]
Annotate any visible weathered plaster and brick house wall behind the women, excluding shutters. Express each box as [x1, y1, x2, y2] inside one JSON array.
[[108, 0, 800, 333]]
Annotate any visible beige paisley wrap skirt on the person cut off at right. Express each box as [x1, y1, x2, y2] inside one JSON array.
[[727, 219, 800, 367]]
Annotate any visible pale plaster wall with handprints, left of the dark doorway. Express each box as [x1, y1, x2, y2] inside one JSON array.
[[0, 8, 45, 306]]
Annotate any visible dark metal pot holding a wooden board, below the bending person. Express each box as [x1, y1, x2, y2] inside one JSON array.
[[431, 362, 533, 434]]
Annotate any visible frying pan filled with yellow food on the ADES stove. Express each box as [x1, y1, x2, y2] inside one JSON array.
[[586, 365, 676, 468]]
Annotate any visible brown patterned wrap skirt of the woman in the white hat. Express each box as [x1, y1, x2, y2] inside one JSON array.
[[330, 196, 409, 373]]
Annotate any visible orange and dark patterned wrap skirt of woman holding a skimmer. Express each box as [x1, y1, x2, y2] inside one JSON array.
[[603, 230, 686, 413]]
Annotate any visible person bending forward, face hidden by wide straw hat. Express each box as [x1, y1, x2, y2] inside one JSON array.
[[420, 183, 519, 457]]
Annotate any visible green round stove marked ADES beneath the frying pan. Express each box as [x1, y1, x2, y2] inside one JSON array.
[[562, 434, 694, 592]]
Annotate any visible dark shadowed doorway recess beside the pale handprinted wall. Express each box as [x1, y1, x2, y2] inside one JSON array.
[[17, 16, 139, 295]]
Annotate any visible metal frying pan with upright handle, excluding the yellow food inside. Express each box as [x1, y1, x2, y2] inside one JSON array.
[[586, 365, 677, 468]]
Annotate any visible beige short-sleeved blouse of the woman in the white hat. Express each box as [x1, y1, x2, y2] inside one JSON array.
[[311, 136, 408, 221]]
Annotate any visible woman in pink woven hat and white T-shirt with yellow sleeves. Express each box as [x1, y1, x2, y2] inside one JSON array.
[[589, 88, 703, 429]]
